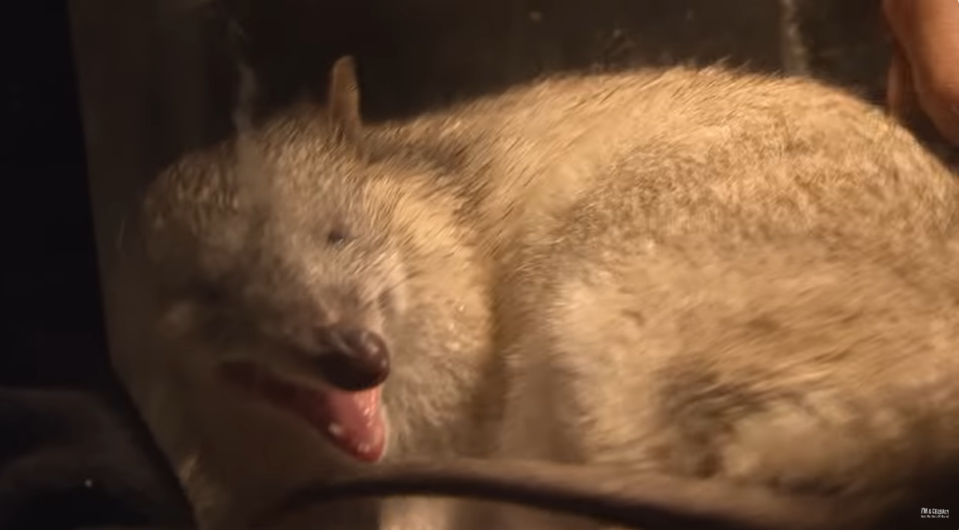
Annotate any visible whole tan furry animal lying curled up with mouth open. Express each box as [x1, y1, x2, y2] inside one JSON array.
[[112, 56, 959, 530]]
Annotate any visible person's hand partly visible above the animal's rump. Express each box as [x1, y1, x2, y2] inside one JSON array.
[[882, 0, 959, 145]]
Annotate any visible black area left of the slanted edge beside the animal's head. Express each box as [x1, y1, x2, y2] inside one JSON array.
[[0, 0, 190, 530]]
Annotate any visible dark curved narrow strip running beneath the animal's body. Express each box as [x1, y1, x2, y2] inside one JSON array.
[[255, 459, 896, 530]]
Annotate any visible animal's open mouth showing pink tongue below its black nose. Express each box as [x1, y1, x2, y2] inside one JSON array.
[[220, 361, 386, 462]]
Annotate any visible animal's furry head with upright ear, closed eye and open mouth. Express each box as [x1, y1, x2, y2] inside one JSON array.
[[144, 58, 485, 461]]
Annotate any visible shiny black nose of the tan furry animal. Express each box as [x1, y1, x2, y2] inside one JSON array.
[[313, 326, 390, 392]]
